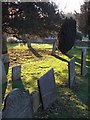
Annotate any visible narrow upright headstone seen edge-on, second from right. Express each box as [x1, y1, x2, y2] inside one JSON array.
[[68, 57, 76, 88]]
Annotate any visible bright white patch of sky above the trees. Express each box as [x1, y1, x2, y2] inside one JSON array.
[[51, 0, 84, 13]]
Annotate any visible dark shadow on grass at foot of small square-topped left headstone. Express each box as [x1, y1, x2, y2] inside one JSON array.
[[12, 79, 25, 90]]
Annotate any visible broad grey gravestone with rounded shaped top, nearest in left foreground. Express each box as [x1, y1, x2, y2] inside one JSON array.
[[2, 88, 33, 118]]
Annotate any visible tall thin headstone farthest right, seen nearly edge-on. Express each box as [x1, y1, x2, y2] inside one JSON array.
[[81, 48, 86, 76]]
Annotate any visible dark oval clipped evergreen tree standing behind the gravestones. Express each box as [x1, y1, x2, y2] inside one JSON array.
[[58, 18, 76, 54]]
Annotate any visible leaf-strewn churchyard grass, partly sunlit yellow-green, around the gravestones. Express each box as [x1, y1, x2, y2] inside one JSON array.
[[2, 44, 90, 118]]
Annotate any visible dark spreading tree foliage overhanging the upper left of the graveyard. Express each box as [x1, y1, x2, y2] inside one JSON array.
[[2, 2, 61, 36]]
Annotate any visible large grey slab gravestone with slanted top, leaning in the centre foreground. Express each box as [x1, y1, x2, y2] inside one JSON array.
[[38, 69, 57, 109]]
